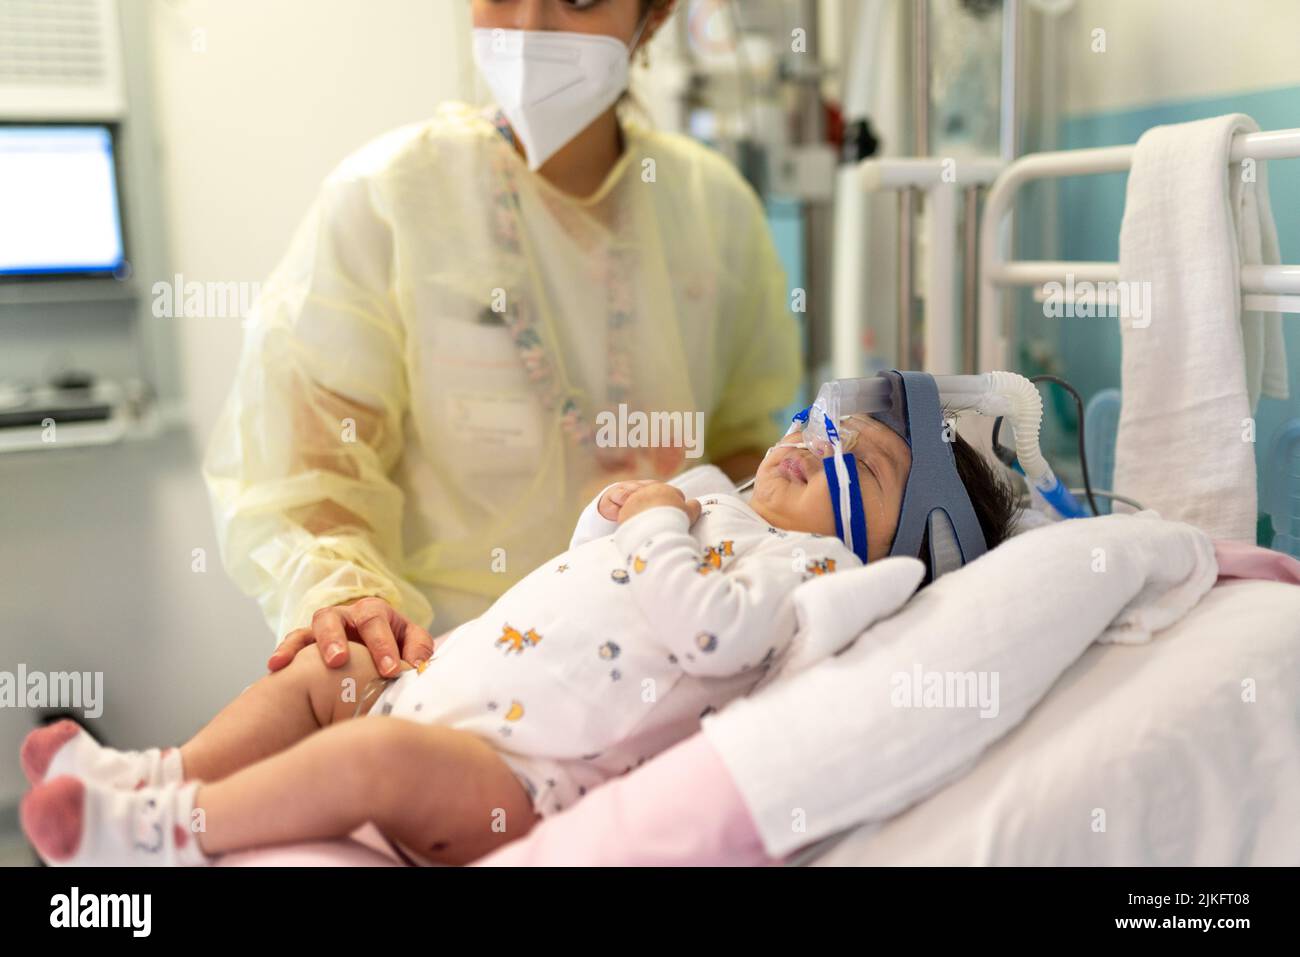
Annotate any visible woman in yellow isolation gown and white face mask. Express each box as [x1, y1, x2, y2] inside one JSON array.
[[205, 0, 800, 675]]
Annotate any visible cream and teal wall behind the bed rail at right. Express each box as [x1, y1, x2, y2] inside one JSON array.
[[1017, 0, 1300, 538]]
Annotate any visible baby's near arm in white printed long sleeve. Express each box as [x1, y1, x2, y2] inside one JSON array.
[[614, 506, 811, 677]]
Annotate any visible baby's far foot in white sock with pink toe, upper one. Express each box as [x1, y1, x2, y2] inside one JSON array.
[[22, 720, 185, 788]]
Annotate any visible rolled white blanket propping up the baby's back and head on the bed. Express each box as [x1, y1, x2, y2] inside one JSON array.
[[703, 512, 1218, 857]]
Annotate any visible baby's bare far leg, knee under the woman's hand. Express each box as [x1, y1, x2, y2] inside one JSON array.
[[181, 644, 380, 781]]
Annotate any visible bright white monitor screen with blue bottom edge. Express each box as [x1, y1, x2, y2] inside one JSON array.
[[0, 125, 126, 280]]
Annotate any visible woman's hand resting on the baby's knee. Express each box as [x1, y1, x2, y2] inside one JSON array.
[[267, 597, 433, 677]]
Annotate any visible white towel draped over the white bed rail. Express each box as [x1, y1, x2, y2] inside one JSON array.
[[1115, 114, 1287, 542]]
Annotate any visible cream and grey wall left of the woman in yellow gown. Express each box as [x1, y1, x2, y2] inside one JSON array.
[[0, 0, 468, 832]]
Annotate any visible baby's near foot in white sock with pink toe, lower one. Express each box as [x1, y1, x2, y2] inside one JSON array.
[[20, 775, 208, 867]]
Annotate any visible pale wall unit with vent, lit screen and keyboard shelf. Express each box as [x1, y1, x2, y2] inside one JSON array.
[[0, 0, 181, 452]]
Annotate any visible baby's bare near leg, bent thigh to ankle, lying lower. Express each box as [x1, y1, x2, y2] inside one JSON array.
[[195, 712, 536, 863]]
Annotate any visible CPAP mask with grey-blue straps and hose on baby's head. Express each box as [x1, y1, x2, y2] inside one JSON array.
[[776, 371, 1084, 580]]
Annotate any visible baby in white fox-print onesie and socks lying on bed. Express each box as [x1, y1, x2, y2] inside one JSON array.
[[22, 417, 1000, 866]]
